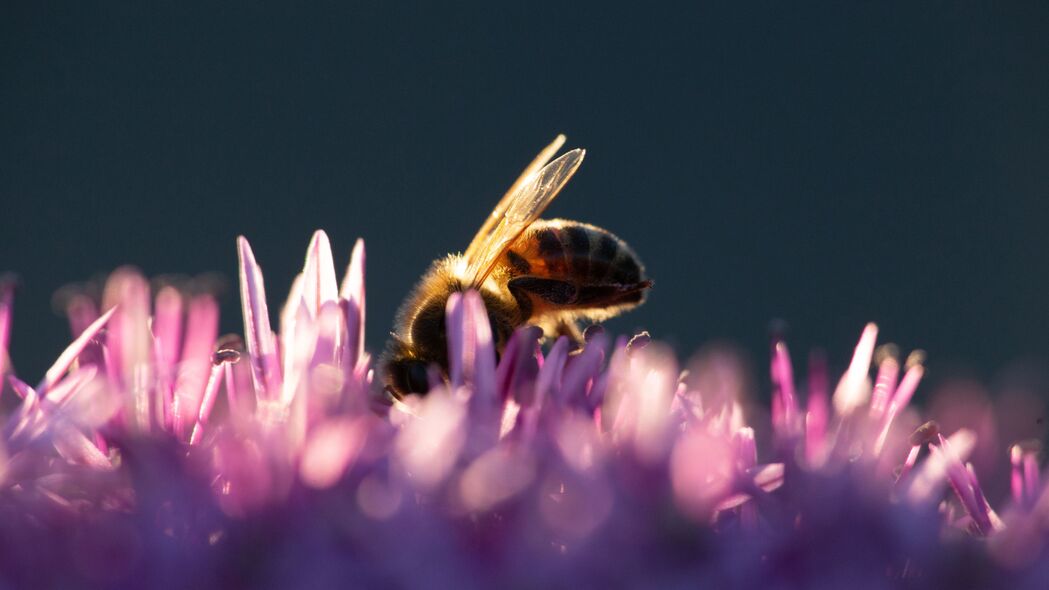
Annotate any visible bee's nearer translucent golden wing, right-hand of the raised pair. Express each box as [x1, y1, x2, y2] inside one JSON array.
[[465, 142, 586, 287]]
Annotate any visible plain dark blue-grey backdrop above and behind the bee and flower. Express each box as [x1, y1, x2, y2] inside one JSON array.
[[0, 1, 1049, 394]]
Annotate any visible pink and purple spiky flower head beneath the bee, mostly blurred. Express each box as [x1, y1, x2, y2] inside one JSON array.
[[0, 232, 1049, 588]]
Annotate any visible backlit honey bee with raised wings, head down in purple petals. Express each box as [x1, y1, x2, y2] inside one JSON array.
[[383, 135, 652, 398]]
